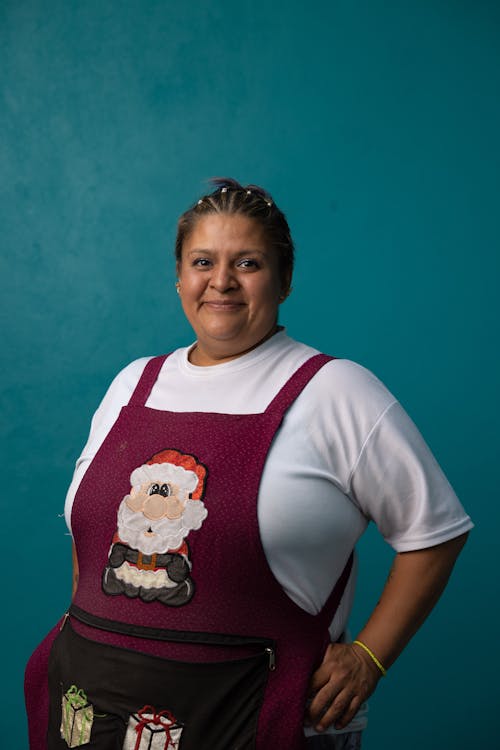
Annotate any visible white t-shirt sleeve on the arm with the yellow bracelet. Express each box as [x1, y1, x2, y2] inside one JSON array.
[[351, 402, 473, 552]]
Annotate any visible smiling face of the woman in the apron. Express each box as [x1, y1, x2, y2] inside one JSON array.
[[177, 214, 283, 365]]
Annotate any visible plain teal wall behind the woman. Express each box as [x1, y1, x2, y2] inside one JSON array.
[[0, 0, 500, 750]]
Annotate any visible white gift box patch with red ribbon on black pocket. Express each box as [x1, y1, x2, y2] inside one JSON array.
[[122, 706, 184, 750]]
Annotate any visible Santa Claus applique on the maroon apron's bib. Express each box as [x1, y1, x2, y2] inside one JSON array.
[[102, 450, 207, 607]]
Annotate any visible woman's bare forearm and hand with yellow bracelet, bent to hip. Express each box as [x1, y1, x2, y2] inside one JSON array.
[[306, 534, 467, 731]]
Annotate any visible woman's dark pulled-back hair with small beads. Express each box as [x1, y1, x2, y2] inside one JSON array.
[[175, 177, 294, 292]]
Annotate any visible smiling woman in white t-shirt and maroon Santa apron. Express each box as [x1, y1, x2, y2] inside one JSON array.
[[26, 180, 472, 750]]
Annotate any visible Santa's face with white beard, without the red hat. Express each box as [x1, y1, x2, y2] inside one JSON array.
[[118, 479, 207, 555]]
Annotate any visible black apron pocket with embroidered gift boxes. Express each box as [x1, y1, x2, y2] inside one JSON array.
[[47, 621, 269, 750]]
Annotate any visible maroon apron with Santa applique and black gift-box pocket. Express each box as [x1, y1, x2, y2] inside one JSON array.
[[26, 355, 352, 750]]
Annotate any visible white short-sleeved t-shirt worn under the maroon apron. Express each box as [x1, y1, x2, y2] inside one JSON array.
[[65, 330, 472, 728]]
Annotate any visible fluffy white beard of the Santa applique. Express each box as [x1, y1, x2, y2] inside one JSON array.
[[118, 498, 207, 555]]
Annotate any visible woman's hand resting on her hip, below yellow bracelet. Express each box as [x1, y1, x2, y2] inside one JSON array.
[[306, 643, 382, 731]]
